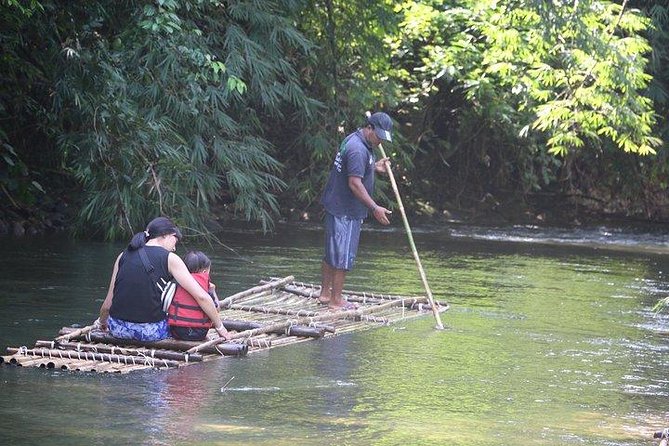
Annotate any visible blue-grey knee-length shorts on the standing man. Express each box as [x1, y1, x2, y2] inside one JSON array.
[[323, 212, 362, 271]]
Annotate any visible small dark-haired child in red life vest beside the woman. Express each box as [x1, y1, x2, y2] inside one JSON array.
[[167, 251, 220, 341]]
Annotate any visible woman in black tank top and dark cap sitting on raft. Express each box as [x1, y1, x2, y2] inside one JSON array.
[[99, 217, 229, 341]]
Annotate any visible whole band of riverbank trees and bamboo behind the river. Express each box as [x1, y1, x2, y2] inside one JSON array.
[[0, 0, 669, 238]]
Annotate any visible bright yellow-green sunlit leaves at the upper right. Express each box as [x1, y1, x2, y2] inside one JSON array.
[[430, 1, 660, 156]]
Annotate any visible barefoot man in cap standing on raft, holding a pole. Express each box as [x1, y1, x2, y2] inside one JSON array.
[[319, 112, 393, 310]]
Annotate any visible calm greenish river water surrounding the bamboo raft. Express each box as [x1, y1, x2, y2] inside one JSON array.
[[0, 224, 669, 446]]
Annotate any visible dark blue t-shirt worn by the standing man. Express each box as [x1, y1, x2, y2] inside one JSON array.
[[321, 129, 376, 218]]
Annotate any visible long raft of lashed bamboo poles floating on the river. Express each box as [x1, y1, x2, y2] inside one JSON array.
[[0, 276, 448, 373]]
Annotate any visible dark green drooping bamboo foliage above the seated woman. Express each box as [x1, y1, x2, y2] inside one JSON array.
[[1, 0, 312, 238]]
